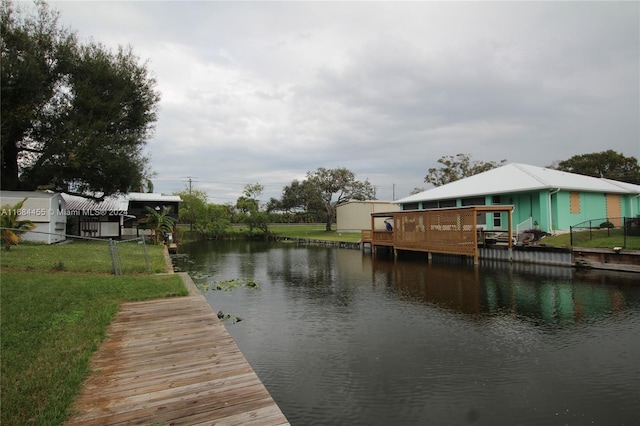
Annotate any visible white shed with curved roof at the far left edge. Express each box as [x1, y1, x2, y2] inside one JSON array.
[[0, 191, 67, 244]]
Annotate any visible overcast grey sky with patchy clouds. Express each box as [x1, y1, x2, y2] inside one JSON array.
[[50, 1, 640, 203]]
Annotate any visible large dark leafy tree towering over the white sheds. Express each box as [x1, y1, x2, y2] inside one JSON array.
[[0, 0, 159, 198]]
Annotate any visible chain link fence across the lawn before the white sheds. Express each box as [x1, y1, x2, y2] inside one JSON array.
[[0, 228, 151, 275]]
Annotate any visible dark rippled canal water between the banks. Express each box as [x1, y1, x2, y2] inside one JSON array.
[[175, 242, 640, 426]]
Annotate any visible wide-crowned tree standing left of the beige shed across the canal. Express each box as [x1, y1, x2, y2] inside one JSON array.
[[282, 167, 376, 232]]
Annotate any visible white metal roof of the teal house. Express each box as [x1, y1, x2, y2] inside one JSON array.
[[396, 163, 640, 204]]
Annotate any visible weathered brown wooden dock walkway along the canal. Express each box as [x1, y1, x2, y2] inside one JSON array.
[[66, 274, 289, 426]]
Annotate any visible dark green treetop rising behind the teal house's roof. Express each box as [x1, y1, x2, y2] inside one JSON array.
[[548, 149, 640, 185]]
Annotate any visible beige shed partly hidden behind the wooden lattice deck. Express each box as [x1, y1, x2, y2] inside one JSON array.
[[336, 200, 400, 232]]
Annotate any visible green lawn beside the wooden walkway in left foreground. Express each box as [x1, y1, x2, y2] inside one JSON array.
[[0, 244, 187, 425]]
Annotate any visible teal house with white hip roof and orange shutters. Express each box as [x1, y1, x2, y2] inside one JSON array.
[[396, 163, 640, 232]]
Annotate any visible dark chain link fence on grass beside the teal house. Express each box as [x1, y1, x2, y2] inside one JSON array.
[[570, 216, 640, 248]]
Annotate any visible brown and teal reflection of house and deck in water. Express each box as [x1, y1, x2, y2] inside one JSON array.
[[372, 260, 637, 324]]
